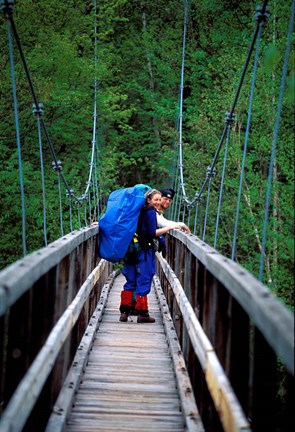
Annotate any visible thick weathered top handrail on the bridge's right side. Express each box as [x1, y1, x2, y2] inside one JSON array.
[[173, 231, 294, 375]]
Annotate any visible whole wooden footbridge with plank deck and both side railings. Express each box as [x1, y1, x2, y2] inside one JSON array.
[[0, 227, 294, 432]]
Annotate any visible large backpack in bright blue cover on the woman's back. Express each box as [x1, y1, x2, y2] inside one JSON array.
[[98, 184, 150, 263]]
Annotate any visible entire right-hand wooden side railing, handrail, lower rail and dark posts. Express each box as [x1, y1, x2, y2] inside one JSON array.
[[157, 231, 295, 432]]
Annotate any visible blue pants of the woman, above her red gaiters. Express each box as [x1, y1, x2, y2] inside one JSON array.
[[122, 249, 156, 296]]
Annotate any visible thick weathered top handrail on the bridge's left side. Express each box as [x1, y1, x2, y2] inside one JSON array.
[[0, 226, 98, 316]]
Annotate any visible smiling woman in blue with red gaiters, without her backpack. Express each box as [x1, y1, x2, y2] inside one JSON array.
[[119, 189, 180, 323]]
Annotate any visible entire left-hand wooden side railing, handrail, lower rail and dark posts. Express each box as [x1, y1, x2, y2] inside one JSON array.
[[0, 227, 112, 432]]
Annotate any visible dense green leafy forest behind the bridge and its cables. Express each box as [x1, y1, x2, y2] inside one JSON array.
[[0, 0, 294, 307]]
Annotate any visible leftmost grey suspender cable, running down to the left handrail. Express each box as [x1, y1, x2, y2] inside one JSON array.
[[8, 20, 27, 256]]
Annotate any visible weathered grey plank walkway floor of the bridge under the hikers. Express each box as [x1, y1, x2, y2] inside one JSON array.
[[60, 275, 203, 432]]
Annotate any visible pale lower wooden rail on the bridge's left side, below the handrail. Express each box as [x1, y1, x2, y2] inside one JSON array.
[[0, 260, 113, 432]]
